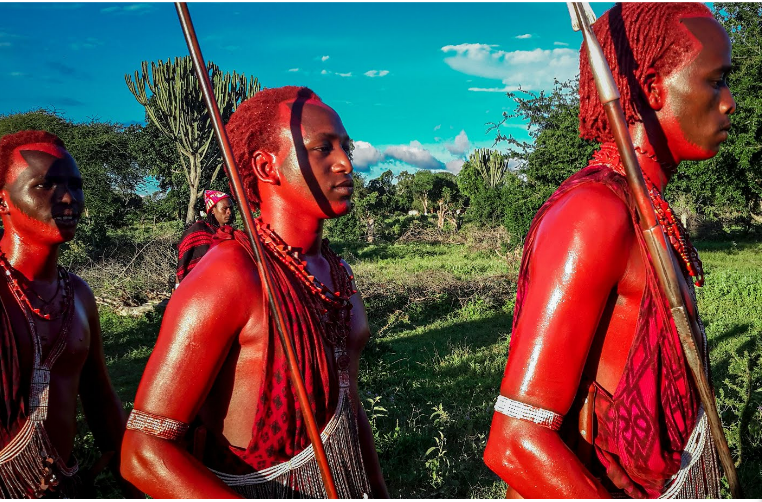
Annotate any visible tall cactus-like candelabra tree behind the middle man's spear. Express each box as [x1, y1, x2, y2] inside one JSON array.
[[125, 56, 260, 223]]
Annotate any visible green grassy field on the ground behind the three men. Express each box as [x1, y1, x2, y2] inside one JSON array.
[[78, 241, 762, 498]]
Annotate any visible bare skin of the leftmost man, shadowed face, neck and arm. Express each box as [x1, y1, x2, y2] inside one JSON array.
[[0, 143, 139, 496]]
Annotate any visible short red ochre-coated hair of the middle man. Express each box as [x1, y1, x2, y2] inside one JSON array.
[[225, 86, 322, 204]]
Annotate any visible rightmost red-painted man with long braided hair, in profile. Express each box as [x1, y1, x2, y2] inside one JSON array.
[[484, 3, 735, 498]]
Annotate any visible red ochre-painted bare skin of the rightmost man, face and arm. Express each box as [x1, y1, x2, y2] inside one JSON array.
[[484, 18, 735, 498]]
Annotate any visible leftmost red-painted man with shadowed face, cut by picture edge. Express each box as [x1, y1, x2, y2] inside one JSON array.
[[0, 131, 142, 498]]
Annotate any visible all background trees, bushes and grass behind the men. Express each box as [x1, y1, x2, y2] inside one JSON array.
[[0, 4, 762, 498]]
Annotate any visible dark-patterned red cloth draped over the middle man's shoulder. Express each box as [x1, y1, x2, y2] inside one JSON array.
[[212, 226, 338, 470]]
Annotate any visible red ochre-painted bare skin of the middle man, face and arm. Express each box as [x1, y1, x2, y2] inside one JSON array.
[[122, 100, 386, 498]]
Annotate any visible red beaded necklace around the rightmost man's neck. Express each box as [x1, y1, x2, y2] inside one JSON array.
[[589, 143, 704, 286]]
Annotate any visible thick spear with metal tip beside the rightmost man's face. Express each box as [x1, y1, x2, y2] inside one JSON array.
[[567, 2, 742, 498]]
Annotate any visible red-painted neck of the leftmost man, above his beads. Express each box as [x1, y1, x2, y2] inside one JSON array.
[[0, 230, 58, 282]]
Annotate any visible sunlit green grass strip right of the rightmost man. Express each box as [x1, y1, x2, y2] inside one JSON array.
[[697, 242, 762, 498]]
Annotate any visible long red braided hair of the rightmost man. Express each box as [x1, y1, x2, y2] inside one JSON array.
[[579, 2, 713, 143]]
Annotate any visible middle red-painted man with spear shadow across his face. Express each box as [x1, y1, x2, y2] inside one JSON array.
[[122, 87, 387, 498]]
